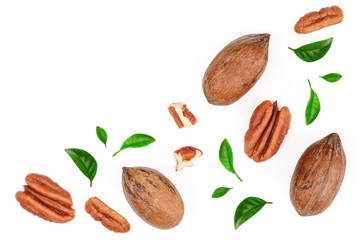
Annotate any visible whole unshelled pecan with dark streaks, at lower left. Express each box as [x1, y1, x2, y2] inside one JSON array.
[[122, 167, 184, 229]]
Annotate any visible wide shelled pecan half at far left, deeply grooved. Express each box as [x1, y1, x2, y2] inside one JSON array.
[[15, 173, 75, 223]]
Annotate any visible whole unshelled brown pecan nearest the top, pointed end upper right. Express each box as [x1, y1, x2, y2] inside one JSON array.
[[202, 33, 270, 105]]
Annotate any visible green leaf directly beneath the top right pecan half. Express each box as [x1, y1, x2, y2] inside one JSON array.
[[289, 37, 334, 62]]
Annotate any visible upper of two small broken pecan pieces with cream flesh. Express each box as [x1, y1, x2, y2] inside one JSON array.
[[168, 102, 197, 128]]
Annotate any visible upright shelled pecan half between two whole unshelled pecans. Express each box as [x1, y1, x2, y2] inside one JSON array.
[[244, 100, 291, 162]]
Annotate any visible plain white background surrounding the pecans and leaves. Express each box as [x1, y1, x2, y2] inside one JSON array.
[[0, 0, 360, 240]]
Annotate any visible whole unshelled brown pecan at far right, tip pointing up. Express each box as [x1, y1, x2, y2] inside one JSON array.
[[290, 133, 346, 216]]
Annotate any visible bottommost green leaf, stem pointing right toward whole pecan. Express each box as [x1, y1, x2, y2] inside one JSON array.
[[234, 197, 272, 229]]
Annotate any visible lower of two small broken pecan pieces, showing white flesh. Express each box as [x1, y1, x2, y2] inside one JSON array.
[[174, 146, 202, 171]]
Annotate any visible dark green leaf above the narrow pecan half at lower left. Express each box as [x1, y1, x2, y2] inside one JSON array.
[[65, 148, 97, 187]]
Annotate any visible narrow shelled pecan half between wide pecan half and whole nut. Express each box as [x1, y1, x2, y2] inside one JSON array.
[[85, 197, 130, 233]]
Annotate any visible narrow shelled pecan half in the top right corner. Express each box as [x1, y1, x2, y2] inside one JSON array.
[[294, 6, 344, 33]]
